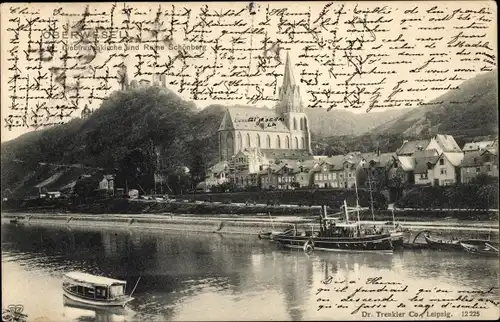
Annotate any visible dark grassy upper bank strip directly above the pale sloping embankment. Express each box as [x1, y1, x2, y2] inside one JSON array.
[[2, 199, 498, 222]]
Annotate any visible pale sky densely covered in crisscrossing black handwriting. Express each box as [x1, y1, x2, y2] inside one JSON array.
[[2, 1, 496, 129]]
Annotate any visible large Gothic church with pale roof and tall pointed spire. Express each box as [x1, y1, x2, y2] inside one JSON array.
[[217, 53, 312, 161]]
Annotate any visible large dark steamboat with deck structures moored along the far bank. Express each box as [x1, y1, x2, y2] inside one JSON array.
[[273, 201, 394, 253]]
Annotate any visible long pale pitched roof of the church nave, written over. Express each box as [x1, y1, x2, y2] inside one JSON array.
[[219, 106, 290, 132]]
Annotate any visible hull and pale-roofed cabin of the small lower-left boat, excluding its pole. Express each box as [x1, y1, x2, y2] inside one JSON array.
[[63, 272, 127, 301]]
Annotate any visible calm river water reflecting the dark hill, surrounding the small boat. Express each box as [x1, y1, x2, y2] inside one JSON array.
[[2, 222, 499, 321]]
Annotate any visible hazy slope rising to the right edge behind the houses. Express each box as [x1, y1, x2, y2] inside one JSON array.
[[370, 70, 498, 139]]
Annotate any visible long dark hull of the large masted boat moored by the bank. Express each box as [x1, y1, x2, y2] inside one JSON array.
[[273, 234, 394, 253]]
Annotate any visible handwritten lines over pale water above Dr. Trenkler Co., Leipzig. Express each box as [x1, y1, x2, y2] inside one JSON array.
[[315, 276, 499, 320]]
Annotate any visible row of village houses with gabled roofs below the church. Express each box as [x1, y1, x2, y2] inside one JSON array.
[[198, 134, 498, 191]]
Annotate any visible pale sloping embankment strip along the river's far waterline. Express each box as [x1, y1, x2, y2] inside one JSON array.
[[2, 214, 498, 239]]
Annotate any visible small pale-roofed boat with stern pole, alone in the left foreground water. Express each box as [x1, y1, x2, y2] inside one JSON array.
[[63, 272, 139, 306]]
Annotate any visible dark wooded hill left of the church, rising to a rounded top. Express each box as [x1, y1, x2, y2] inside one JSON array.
[[1, 87, 207, 194]]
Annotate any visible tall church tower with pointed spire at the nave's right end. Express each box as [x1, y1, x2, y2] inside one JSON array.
[[275, 52, 312, 153]]
